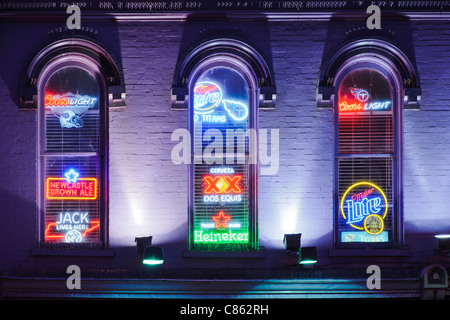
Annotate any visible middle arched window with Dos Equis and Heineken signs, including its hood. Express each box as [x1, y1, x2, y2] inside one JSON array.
[[172, 39, 275, 251]]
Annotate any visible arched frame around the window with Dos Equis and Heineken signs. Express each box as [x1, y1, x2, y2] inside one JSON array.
[[187, 53, 259, 252]]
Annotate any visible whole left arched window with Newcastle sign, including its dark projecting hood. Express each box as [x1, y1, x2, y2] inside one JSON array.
[[25, 38, 125, 248]]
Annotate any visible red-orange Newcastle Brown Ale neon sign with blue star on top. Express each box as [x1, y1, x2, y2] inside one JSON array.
[[46, 169, 97, 200]]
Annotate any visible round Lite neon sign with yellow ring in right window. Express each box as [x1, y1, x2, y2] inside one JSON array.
[[340, 182, 388, 235]]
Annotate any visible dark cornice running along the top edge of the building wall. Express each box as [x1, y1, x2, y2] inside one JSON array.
[[0, 0, 450, 21]]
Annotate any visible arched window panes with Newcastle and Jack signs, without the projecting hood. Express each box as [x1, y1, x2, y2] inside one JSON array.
[[38, 59, 106, 246]]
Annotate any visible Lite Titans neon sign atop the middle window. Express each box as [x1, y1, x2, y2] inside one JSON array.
[[194, 82, 248, 123]]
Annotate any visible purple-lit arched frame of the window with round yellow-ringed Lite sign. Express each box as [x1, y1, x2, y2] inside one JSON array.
[[333, 53, 404, 249]]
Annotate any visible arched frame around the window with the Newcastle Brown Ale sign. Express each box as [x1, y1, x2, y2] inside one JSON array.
[[36, 54, 109, 249]]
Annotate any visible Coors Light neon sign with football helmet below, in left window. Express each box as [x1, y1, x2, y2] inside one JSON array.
[[44, 93, 97, 128]]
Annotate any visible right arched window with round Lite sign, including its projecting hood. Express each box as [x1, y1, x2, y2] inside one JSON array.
[[317, 38, 421, 249]]
